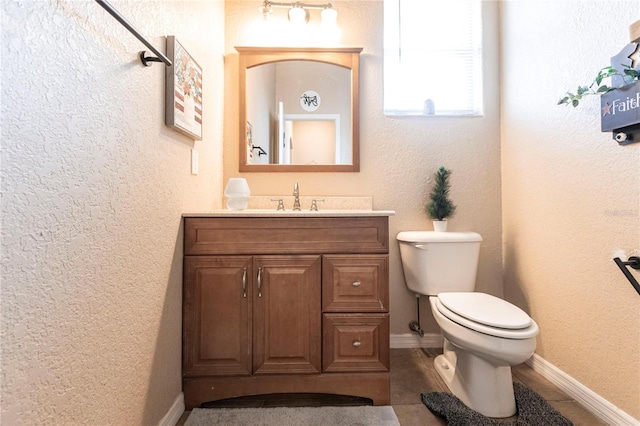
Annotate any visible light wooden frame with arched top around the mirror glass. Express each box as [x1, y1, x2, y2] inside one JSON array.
[[235, 46, 362, 172]]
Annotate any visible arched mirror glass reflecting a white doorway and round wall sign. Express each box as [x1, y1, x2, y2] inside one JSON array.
[[245, 61, 352, 164]]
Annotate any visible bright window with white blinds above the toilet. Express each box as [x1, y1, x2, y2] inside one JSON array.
[[384, 0, 482, 115]]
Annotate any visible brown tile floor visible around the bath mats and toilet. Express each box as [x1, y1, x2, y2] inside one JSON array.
[[177, 348, 606, 426]]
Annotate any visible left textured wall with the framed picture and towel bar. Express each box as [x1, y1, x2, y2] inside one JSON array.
[[0, 0, 224, 425]]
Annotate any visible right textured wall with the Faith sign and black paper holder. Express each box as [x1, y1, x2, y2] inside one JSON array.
[[502, 1, 640, 419]]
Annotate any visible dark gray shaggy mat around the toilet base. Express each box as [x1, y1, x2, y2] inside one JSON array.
[[420, 383, 573, 426]]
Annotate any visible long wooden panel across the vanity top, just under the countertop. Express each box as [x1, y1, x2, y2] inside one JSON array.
[[184, 216, 389, 255]]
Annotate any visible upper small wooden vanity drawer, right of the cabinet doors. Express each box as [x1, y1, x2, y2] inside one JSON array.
[[322, 255, 389, 312]]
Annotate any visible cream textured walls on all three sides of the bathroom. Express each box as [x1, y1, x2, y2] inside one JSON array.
[[6, 0, 640, 424]]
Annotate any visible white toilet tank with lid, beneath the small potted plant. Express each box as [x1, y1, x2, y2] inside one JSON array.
[[396, 231, 482, 296]]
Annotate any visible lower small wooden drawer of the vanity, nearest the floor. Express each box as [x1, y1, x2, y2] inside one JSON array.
[[322, 314, 389, 373]]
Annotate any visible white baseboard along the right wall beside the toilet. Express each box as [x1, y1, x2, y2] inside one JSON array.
[[527, 354, 640, 426]]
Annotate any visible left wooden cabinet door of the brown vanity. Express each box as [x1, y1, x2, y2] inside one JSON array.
[[182, 256, 252, 376]]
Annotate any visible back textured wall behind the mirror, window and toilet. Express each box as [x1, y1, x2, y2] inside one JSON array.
[[224, 1, 502, 334]]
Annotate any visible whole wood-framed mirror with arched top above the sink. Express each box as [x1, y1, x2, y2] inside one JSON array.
[[236, 47, 362, 172]]
